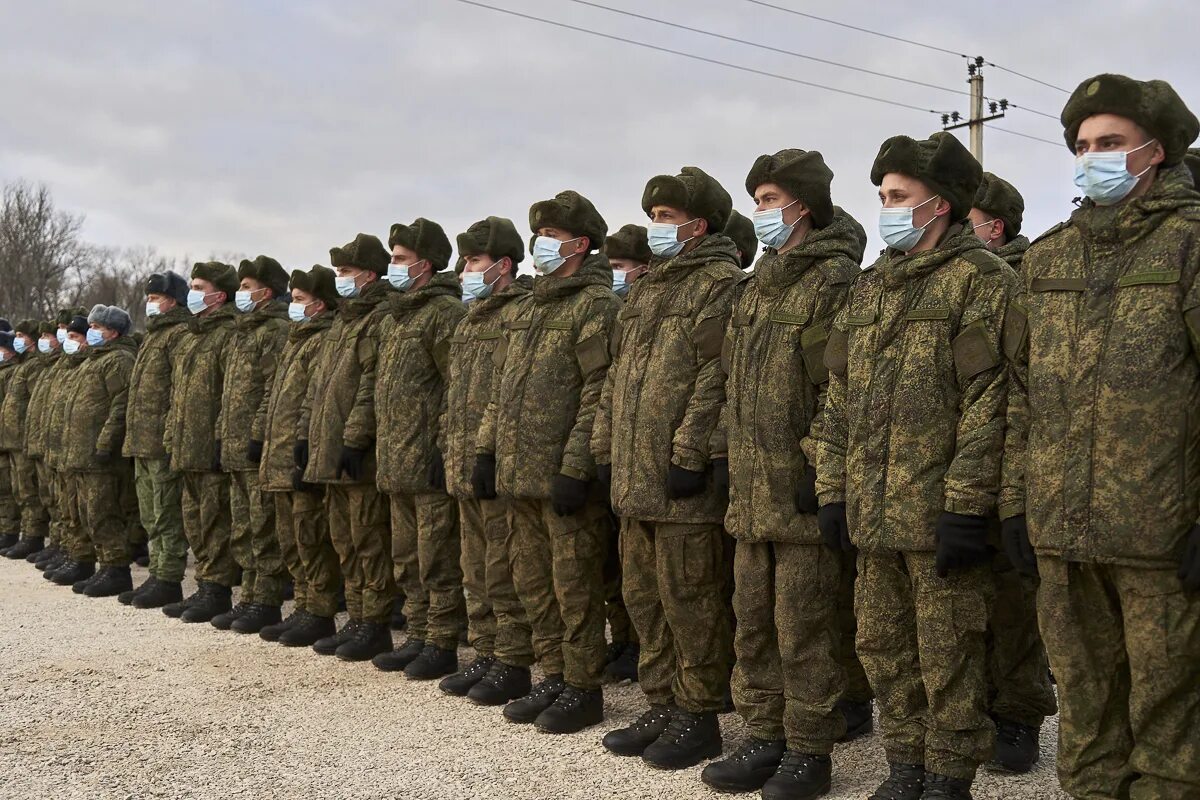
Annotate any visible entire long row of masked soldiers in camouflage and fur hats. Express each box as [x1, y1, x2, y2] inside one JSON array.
[[0, 74, 1200, 800]]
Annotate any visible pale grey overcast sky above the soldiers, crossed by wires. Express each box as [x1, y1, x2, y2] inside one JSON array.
[[0, 0, 1200, 269]]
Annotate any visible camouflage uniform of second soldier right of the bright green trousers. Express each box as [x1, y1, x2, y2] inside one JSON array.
[[216, 300, 288, 606]]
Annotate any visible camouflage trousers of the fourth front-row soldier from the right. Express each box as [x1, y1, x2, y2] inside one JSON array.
[[620, 518, 733, 714]]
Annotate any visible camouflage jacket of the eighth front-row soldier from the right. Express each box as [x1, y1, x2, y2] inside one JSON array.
[[300, 281, 396, 483]]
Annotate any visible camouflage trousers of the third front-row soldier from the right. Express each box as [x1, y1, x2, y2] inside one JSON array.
[[732, 542, 871, 756]]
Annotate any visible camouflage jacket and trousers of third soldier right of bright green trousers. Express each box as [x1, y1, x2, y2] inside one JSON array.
[[261, 311, 342, 616]]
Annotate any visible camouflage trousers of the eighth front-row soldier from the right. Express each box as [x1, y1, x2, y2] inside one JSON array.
[[325, 483, 396, 622]]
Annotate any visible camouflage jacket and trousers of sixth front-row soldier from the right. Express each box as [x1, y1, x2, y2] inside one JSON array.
[[438, 277, 533, 667]]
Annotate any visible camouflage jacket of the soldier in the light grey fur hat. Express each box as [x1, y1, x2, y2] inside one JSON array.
[[60, 336, 138, 471]]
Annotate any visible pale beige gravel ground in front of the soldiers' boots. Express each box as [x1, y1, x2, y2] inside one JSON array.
[[0, 559, 1066, 800]]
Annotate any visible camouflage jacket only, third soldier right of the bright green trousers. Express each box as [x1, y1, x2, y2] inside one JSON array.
[[258, 311, 336, 492]]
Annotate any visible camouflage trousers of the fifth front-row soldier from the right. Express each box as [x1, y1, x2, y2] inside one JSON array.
[[509, 499, 611, 691]]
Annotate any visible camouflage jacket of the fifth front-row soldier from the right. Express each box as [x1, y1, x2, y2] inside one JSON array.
[[476, 253, 620, 499]]
